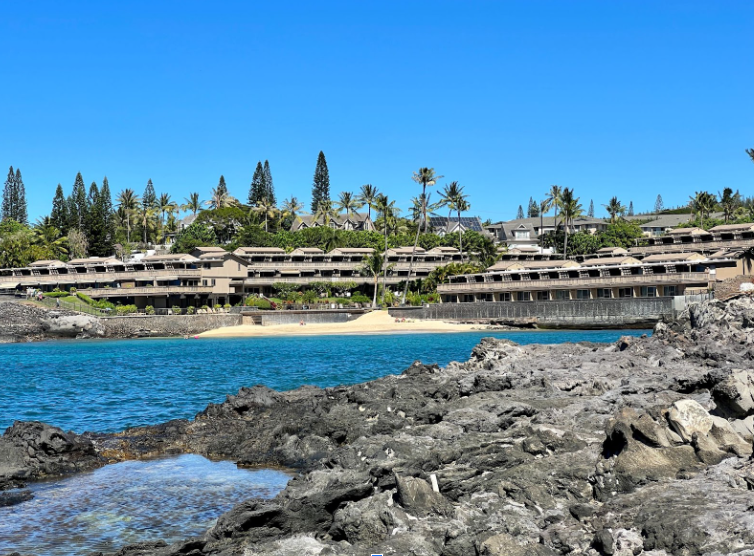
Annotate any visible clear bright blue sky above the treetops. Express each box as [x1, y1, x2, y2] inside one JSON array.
[[0, 0, 754, 224]]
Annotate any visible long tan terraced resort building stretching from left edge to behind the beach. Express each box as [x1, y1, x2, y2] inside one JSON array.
[[0, 247, 464, 309]]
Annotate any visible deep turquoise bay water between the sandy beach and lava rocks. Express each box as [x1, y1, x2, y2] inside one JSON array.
[[0, 330, 648, 432]]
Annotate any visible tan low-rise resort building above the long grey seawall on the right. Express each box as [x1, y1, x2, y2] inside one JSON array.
[[437, 250, 745, 303]]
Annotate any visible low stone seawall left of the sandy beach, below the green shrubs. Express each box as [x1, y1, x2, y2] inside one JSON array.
[[100, 313, 241, 338]]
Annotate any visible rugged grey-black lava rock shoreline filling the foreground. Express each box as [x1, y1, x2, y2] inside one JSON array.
[[0, 298, 754, 556]]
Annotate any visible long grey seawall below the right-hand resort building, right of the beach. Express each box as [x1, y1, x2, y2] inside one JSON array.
[[390, 297, 677, 328]]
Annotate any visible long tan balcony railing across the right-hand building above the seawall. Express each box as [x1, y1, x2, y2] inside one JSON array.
[[437, 272, 710, 293]]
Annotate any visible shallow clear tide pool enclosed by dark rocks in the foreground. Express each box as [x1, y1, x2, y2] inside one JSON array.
[[0, 455, 291, 556]]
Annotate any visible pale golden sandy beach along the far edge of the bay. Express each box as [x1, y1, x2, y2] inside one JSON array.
[[194, 311, 480, 338]]
